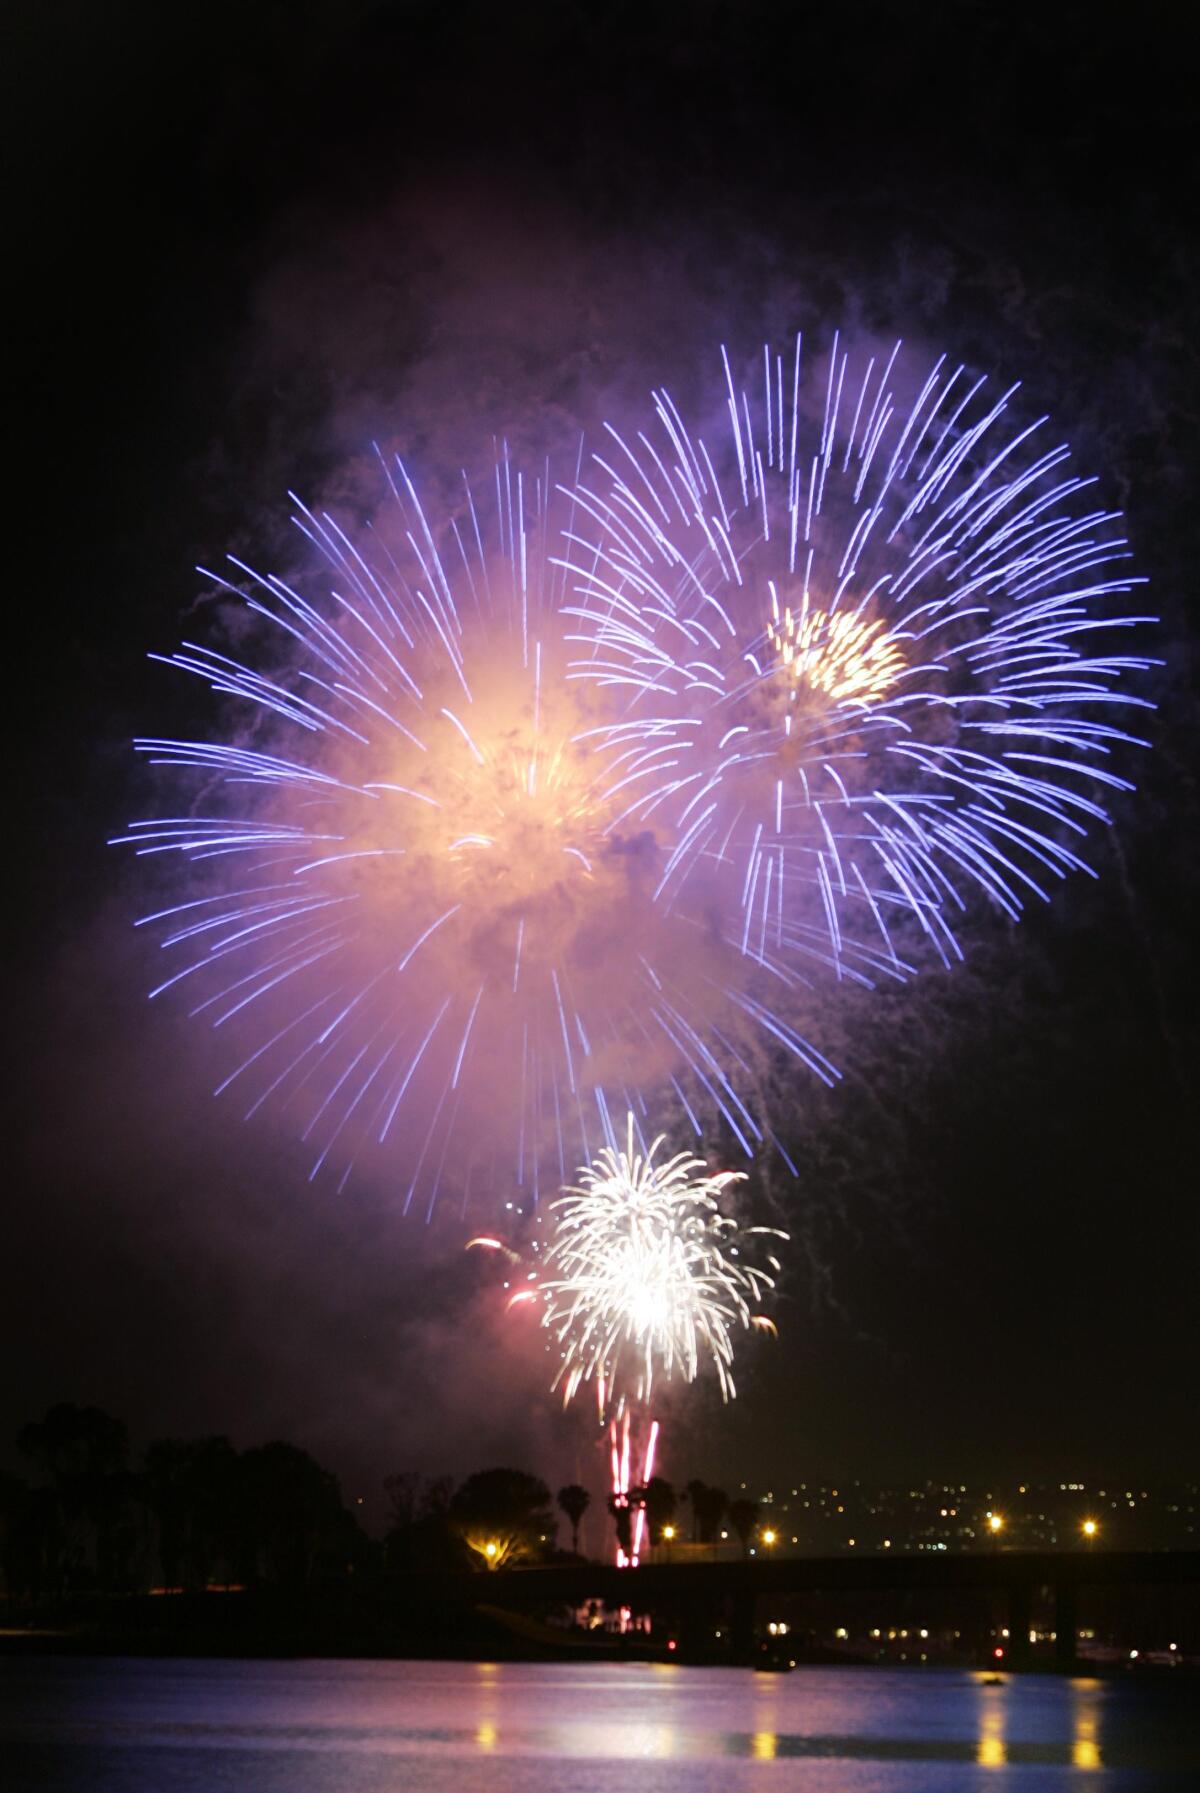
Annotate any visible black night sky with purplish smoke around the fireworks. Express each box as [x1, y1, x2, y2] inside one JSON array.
[[11, 0, 1200, 1520]]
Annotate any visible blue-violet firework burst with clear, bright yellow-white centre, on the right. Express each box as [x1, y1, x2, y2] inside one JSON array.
[[567, 337, 1157, 982]]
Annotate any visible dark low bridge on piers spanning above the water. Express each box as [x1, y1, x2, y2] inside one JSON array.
[[456, 1549, 1200, 1666]]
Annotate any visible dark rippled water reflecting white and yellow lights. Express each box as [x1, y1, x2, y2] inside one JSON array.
[[0, 1659, 1200, 1793]]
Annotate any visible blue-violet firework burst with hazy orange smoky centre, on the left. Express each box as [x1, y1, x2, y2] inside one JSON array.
[[118, 454, 834, 1214]]
